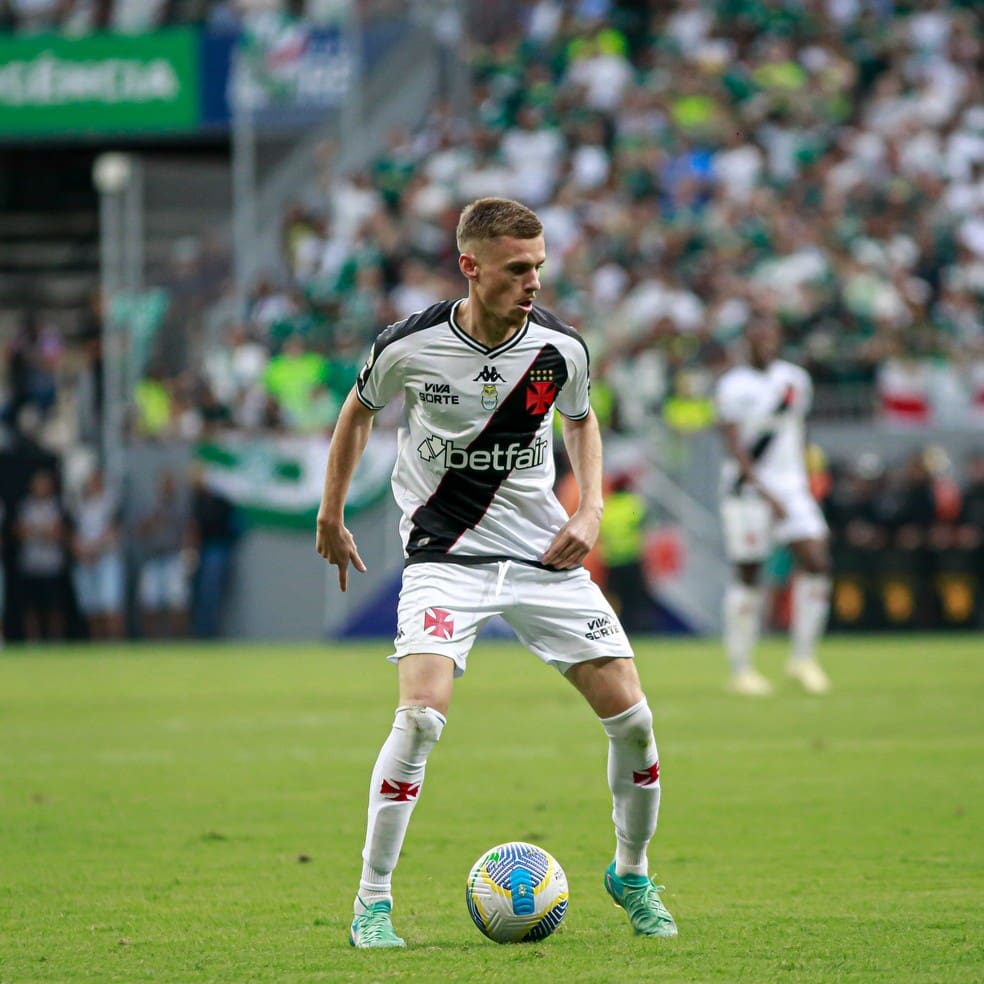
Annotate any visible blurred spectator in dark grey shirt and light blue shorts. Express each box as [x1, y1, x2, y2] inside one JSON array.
[[136, 472, 188, 639]]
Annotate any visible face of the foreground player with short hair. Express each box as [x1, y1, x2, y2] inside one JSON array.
[[463, 236, 547, 325]]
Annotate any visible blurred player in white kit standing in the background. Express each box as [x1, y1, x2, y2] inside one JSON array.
[[715, 316, 830, 697]]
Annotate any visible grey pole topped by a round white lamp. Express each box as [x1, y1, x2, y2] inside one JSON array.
[[92, 153, 133, 508]]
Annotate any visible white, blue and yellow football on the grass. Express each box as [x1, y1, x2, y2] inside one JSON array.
[[465, 841, 568, 943]]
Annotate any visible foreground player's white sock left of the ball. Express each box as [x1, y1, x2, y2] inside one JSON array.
[[355, 707, 446, 915]]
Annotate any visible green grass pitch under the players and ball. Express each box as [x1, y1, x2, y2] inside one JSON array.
[[0, 636, 984, 984]]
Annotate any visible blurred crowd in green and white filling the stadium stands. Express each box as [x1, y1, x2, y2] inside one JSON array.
[[183, 0, 984, 429]]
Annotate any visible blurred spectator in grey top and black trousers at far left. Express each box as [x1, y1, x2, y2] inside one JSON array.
[[16, 470, 69, 641]]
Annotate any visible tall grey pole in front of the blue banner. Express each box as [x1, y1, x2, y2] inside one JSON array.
[[232, 47, 257, 317]]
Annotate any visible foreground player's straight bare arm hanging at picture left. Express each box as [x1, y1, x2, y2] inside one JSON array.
[[316, 388, 375, 591]]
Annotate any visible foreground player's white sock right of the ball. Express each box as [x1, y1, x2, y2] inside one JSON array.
[[601, 698, 660, 877]]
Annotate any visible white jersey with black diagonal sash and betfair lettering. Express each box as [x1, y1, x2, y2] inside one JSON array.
[[356, 301, 590, 564]]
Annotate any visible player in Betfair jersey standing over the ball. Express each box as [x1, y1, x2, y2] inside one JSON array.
[[317, 198, 677, 948]]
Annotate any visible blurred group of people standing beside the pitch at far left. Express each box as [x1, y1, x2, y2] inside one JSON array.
[[0, 460, 242, 644]]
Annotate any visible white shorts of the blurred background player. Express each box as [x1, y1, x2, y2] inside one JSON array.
[[721, 489, 827, 564]]
